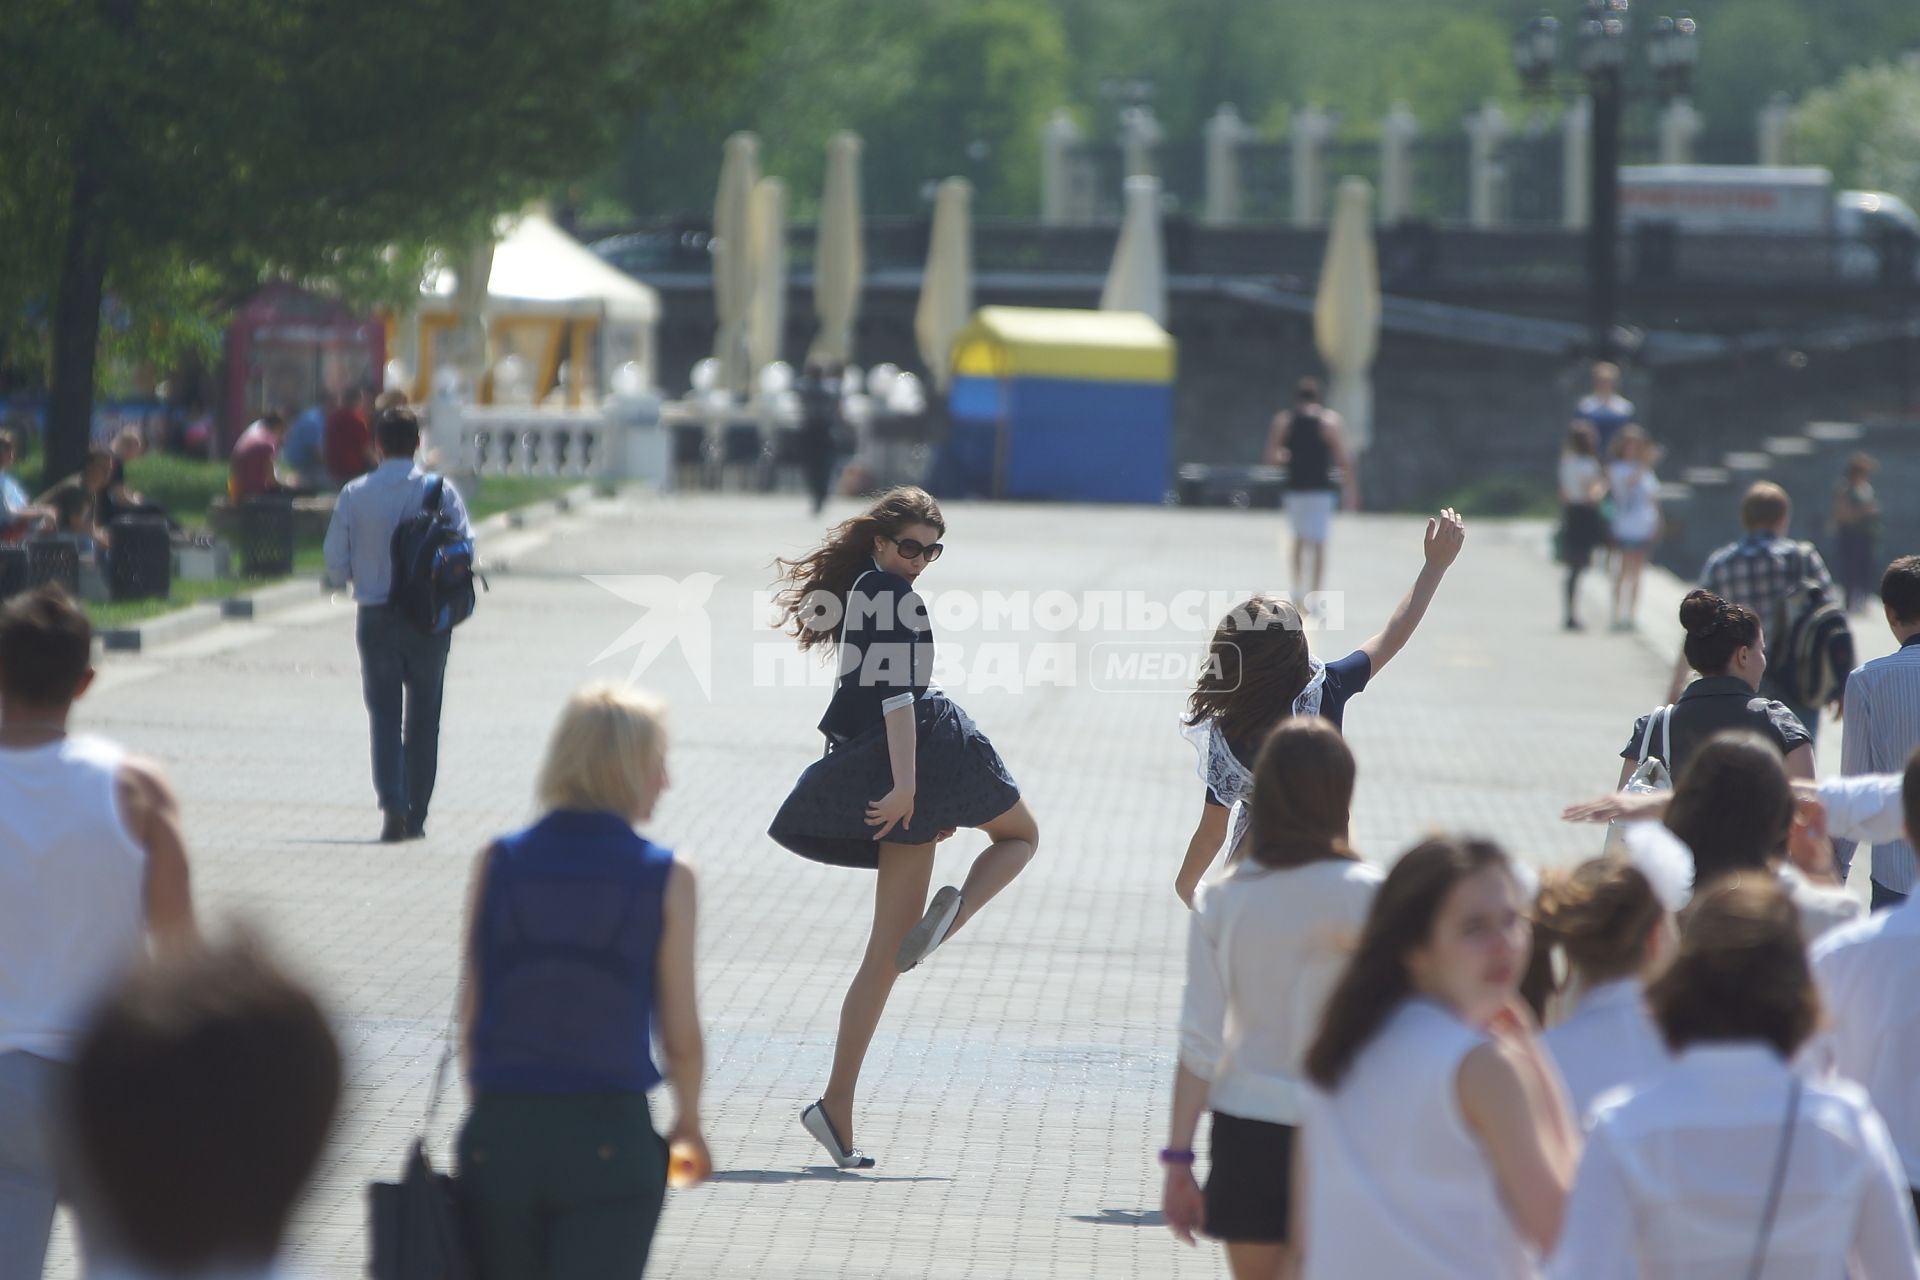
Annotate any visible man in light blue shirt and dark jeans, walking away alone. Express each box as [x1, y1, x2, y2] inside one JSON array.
[[326, 409, 472, 844]]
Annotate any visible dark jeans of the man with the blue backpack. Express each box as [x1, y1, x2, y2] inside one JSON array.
[[355, 604, 453, 827]]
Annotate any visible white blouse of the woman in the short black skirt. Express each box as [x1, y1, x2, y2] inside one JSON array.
[[1181, 858, 1386, 1125]]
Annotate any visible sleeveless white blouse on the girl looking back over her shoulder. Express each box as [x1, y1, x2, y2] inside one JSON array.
[[1302, 998, 1538, 1280]]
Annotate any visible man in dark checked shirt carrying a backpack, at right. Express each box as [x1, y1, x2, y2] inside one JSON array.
[[1667, 480, 1850, 744]]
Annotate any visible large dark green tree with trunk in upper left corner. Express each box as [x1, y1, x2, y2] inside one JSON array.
[[0, 0, 762, 485]]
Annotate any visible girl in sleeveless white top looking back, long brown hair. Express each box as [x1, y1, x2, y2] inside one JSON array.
[[1294, 839, 1580, 1280]]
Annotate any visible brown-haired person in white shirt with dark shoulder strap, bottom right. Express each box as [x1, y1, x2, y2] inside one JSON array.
[[1551, 871, 1920, 1280]]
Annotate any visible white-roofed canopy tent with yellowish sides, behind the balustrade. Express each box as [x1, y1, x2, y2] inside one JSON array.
[[412, 213, 660, 405]]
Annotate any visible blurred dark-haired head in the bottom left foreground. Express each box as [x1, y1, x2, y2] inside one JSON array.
[[67, 940, 340, 1280]]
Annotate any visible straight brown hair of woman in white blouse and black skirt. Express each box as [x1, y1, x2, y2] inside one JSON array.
[[1246, 716, 1356, 869]]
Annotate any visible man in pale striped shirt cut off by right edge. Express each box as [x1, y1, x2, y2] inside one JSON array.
[[1839, 557, 1920, 912]]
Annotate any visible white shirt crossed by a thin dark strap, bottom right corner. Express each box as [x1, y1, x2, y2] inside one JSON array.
[[1549, 1042, 1920, 1280]]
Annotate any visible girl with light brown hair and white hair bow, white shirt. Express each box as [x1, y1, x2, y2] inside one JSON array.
[[1534, 858, 1672, 1119]]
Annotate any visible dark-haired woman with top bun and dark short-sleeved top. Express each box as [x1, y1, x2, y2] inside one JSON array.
[[1617, 591, 1812, 787]]
